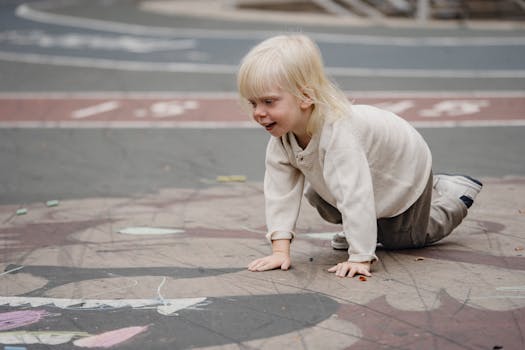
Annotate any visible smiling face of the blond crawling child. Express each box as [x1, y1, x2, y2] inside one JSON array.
[[248, 88, 312, 137]]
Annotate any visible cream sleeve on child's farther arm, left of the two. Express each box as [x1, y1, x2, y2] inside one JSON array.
[[264, 137, 304, 241]]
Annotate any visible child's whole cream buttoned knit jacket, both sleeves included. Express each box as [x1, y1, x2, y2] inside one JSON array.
[[264, 105, 432, 262]]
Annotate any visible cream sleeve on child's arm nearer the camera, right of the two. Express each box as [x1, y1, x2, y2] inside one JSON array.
[[323, 127, 377, 262]]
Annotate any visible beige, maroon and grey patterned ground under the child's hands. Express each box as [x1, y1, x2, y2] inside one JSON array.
[[0, 177, 525, 349]]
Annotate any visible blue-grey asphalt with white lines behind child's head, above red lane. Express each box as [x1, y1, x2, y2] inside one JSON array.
[[0, 1, 525, 91]]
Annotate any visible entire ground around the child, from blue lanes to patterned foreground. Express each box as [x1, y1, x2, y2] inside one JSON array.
[[0, 0, 525, 350]]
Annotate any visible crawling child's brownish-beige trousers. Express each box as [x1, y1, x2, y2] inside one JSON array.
[[305, 173, 467, 249]]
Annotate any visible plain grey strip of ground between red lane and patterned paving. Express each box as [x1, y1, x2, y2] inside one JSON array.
[[0, 127, 525, 205]]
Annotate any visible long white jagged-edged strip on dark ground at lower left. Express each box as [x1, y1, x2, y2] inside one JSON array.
[[0, 296, 206, 316]]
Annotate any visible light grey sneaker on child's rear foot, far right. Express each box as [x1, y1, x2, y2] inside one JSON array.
[[434, 174, 483, 208]]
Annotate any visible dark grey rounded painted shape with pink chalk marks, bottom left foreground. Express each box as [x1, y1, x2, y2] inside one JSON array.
[[0, 292, 340, 349]]
